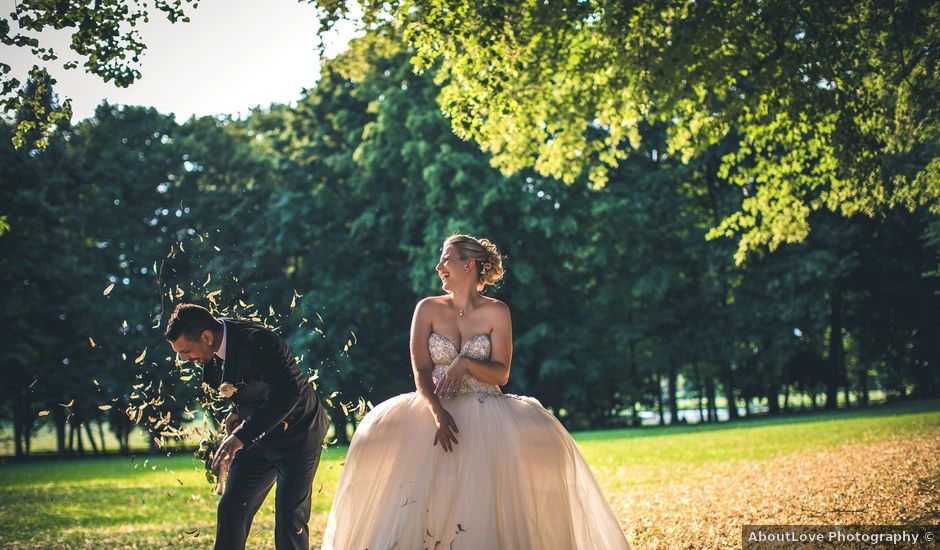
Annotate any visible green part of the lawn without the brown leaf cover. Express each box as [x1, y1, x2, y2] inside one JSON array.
[[0, 401, 940, 548]]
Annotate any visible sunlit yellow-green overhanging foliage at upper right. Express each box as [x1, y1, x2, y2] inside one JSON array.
[[319, 0, 940, 264]]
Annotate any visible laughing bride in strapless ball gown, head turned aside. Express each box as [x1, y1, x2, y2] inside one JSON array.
[[323, 235, 629, 550]]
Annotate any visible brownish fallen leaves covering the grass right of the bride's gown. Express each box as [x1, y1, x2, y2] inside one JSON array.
[[599, 432, 940, 549]]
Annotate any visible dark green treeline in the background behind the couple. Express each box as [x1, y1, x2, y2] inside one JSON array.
[[0, 34, 940, 455]]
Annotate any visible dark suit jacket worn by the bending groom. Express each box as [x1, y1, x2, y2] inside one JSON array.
[[202, 318, 330, 450]]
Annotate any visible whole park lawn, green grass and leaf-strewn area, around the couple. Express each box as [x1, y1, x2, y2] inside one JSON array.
[[0, 401, 940, 548]]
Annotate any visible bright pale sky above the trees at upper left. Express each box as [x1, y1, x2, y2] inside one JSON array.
[[0, 0, 362, 122]]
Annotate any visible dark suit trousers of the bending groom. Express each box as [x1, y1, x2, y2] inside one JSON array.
[[215, 437, 322, 550]]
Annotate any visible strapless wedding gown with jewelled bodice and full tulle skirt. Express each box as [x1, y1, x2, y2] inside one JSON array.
[[323, 333, 629, 550]]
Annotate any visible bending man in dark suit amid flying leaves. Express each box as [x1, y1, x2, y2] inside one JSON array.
[[164, 304, 329, 550]]
